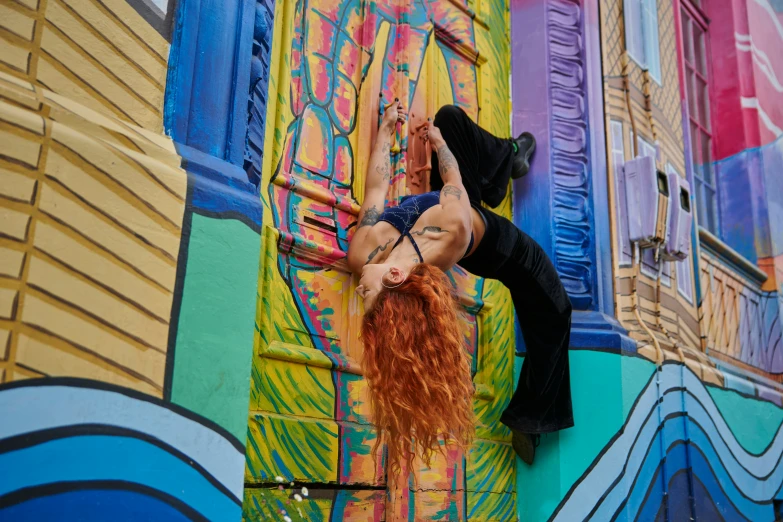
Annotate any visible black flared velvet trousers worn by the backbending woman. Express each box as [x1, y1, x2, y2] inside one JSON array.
[[430, 105, 574, 433]]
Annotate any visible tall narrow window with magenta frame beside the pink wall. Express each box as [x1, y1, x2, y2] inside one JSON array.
[[681, 0, 720, 235]]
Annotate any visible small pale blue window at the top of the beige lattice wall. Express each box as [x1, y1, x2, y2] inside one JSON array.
[[624, 0, 661, 83]]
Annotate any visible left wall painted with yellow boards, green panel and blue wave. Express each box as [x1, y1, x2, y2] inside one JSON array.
[[0, 0, 260, 520]]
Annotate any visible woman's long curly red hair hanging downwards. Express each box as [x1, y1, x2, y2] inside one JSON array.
[[362, 263, 474, 481]]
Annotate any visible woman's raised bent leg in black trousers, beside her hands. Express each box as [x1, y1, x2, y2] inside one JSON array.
[[430, 105, 514, 207]]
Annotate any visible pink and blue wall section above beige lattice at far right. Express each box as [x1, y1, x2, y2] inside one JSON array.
[[700, 1, 783, 381]]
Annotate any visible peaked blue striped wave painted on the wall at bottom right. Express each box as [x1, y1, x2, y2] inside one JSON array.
[[553, 364, 783, 521]]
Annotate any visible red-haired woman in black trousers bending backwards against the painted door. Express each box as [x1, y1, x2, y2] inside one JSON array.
[[348, 103, 574, 474]]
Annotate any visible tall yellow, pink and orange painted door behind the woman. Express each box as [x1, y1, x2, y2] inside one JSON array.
[[245, 0, 516, 521]]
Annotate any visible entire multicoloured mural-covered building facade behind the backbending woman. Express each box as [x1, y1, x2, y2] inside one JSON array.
[[0, 0, 783, 522]]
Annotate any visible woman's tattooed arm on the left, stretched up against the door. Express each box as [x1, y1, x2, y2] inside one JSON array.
[[348, 101, 405, 273]]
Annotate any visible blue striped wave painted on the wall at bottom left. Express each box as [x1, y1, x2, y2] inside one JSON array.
[[0, 378, 244, 521]]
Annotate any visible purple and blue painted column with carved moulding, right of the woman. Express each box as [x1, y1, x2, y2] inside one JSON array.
[[511, 0, 634, 349]]
